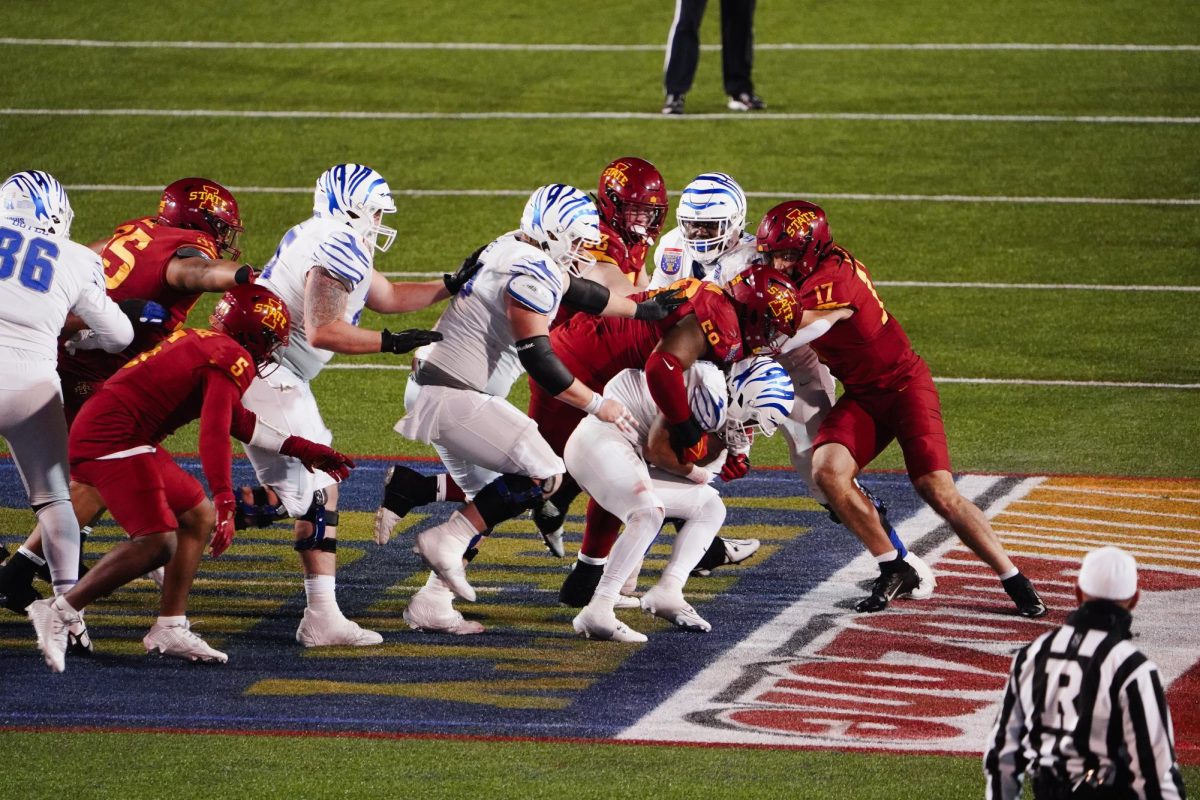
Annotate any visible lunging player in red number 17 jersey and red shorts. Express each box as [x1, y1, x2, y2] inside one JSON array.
[[757, 200, 1046, 616]]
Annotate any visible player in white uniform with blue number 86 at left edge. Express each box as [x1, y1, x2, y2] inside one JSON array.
[[0, 170, 133, 636]]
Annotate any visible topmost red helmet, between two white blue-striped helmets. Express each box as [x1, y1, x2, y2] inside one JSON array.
[[596, 157, 667, 246]]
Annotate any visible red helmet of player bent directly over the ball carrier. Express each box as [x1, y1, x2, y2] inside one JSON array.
[[725, 264, 804, 356]]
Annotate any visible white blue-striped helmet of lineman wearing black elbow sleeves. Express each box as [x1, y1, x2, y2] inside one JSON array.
[[521, 184, 600, 277]]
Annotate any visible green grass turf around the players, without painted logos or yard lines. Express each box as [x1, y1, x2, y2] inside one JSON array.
[[0, 0, 1200, 800]]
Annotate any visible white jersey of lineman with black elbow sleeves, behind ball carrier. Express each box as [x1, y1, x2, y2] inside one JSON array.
[[424, 231, 568, 397]]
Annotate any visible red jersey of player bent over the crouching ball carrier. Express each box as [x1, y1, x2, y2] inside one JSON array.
[[550, 278, 742, 391]]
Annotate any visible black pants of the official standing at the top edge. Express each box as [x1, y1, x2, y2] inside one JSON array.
[[662, 0, 755, 95]]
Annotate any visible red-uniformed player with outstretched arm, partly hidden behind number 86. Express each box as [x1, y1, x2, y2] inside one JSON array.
[[0, 178, 254, 618]]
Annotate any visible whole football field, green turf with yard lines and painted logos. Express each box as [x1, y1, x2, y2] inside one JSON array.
[[0, 0, 1200, 799]]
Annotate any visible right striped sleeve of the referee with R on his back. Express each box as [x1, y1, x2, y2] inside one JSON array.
[[1121, 662, 1183, 800]]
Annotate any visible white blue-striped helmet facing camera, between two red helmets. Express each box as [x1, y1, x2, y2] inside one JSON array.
[[676, 173, 746, 264]]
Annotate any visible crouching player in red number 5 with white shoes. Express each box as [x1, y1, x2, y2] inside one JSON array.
[[29, 284, 354, 672]]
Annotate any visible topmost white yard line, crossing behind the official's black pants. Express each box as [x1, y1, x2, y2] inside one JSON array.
[[0, 36, 1200, 53]]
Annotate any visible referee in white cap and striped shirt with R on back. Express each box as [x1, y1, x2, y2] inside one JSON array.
[[983, 547, 1186, 800]]
